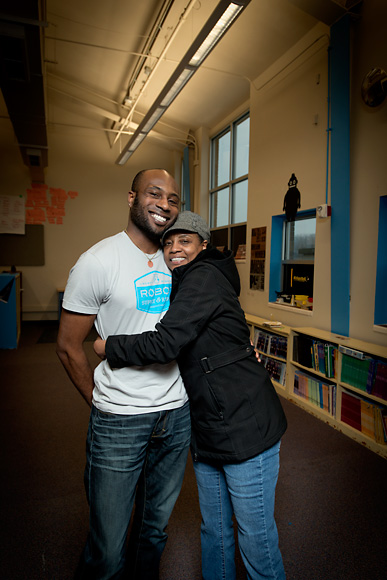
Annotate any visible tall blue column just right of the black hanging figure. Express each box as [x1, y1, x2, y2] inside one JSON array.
[[330, 16, 350, 336]]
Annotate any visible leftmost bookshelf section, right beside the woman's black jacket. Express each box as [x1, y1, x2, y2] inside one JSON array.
[[246, 314, 290, 394]]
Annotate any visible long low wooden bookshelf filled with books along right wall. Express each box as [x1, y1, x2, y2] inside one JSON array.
[[246, 314, 387, 459]]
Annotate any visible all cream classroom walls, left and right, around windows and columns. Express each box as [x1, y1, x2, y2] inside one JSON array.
[[0, 0, 387, 344]]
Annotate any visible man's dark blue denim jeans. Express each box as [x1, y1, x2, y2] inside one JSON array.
[[80, 403, 191, 580]]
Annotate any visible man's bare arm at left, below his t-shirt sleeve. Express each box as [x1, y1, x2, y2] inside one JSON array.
[[56, 309, 96, 406]]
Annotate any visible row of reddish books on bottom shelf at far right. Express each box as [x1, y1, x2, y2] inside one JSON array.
[[341, 391, 387, 443]]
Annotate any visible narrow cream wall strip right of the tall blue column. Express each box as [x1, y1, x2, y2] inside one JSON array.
[[350, 0, 387, 345]]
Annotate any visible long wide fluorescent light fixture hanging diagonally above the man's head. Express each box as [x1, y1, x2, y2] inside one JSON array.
[[116, 0, 251, 165]]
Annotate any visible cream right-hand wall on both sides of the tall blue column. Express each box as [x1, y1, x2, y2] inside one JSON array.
[[233, 0, 387, 345]]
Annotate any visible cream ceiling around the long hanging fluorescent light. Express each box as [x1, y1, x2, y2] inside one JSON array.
[[0, 0, 360, 174]]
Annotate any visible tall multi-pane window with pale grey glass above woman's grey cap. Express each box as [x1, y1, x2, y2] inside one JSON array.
[[210, 114, 250, 254]]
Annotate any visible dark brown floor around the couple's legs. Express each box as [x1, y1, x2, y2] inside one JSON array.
[[0, 323, 387, 580]]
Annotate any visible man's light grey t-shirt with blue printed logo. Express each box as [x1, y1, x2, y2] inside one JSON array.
[[63, 232, 187, 415]]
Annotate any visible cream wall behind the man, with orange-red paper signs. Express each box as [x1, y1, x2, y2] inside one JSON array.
[[0, 124, 180, 320]]
